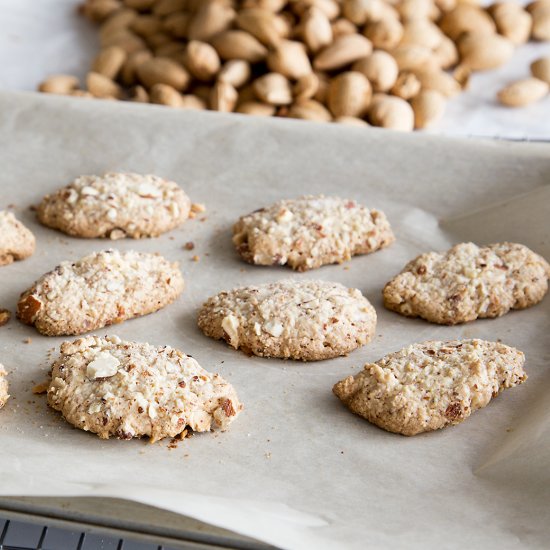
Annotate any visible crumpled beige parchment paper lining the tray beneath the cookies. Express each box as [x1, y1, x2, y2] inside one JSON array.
[[0, 93, 550, 548]]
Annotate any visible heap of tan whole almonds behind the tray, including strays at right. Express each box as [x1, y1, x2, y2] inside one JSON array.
[[39, 0, 550, 131]]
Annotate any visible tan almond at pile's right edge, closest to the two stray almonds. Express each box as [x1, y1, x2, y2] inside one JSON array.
[[458, 34, 514, 71]]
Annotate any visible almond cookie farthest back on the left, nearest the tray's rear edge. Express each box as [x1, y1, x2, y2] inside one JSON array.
[[37, 172, 191, 239]]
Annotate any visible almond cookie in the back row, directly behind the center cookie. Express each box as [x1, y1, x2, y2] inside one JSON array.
[[233, 195, 395, 271]]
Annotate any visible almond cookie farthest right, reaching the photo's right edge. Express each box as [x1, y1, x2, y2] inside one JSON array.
[[384, 243, 550, 325]]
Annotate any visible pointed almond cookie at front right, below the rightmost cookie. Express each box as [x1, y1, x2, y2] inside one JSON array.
[[333, 340, 527, 435]]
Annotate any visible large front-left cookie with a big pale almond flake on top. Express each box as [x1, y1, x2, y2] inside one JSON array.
[[48, 336, 242, 441]]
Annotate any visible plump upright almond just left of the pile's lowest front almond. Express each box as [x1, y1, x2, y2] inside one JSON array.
[[328, 71, 372, 117]]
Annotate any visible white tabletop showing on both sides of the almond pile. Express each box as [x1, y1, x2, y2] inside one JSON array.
[[0, 0, 550, 139]]
